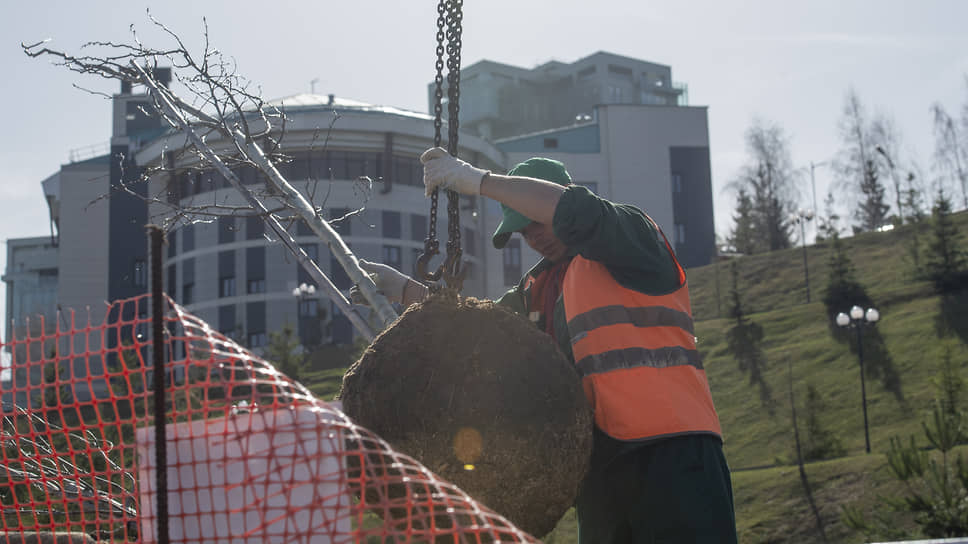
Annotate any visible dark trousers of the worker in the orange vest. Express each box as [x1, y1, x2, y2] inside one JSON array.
[[576, 429, 736, 544]]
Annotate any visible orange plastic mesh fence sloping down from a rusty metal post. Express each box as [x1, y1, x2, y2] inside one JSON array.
[[0, 296, 535, 543]]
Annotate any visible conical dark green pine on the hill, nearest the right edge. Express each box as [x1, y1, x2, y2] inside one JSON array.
[[924, 190, 968, 293]]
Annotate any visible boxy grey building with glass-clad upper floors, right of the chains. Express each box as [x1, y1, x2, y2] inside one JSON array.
[[458, 52, 715, 270]]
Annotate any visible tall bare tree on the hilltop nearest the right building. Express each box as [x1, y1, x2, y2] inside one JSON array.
[[731, 119, 797, 251]]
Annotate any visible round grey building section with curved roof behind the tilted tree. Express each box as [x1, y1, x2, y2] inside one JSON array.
[[137, 94, 504, 348]]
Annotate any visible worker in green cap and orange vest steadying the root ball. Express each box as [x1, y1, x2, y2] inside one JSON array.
[[362, 148, 736, 544]]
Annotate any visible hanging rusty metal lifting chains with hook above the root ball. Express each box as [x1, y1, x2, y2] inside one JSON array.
[[417, 0, 464, 291]]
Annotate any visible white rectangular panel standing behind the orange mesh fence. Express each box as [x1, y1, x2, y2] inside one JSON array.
[[137, 406, 352, 544]]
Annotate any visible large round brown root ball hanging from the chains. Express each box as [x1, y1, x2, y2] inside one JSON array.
[[340, 294, 593, 537]]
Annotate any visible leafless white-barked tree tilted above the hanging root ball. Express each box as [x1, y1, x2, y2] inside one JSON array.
[[22, 13, 397, 340]]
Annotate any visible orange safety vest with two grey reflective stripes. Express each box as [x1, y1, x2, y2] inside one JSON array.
[[562, 253, 722, 440]]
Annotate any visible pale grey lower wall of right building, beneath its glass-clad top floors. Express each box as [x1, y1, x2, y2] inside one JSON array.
[[500, 104, 715, 278]]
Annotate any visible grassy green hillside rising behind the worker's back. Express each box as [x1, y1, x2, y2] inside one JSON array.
[[308, 213, 968, 544]]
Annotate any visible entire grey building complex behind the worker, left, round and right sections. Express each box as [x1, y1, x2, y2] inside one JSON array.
[[5, 52, 714, 362]]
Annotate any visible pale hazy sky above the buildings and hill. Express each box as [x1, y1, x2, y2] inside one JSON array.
[[0, 0, 968, 330]]
